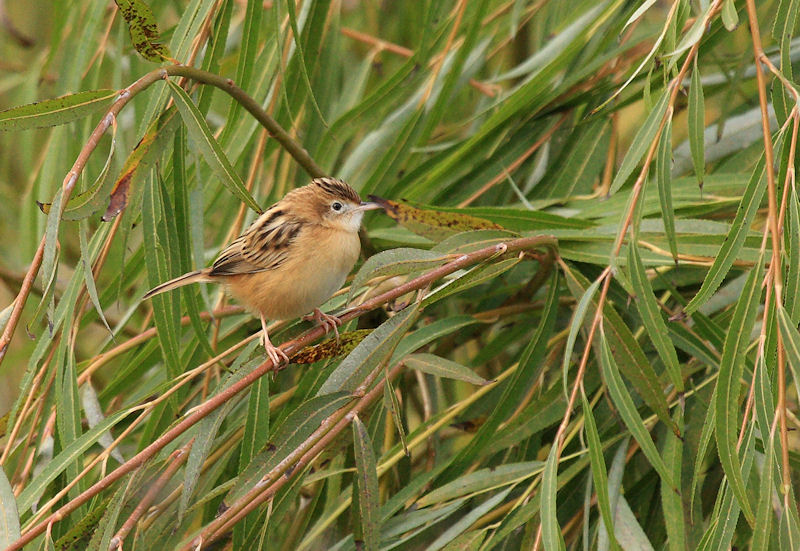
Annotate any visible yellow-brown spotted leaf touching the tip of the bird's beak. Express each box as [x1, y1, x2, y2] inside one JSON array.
[[369, 195, 503, 241]]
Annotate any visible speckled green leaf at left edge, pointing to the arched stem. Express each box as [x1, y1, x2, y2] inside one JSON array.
[[0, 90, 118, 132]]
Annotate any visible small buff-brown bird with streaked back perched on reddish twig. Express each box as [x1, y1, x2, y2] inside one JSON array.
[[144, 178, 381, 365]]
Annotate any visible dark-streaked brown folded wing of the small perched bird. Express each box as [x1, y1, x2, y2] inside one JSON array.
[[209, 204, 303, 276]]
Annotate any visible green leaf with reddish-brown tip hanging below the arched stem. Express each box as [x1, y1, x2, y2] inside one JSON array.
[[103, 107, 180, 222]]
